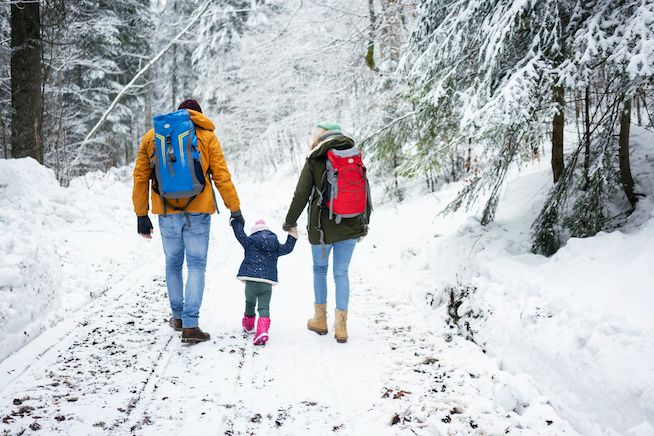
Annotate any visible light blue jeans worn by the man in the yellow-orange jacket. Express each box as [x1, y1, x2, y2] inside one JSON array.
[[159, 213, 211, 328]]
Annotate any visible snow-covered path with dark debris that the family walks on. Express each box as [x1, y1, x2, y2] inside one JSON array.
[[0, 175, 574, 435]]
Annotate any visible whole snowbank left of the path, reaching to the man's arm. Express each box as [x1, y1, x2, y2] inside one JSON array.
[[0, 159, 156, 361]]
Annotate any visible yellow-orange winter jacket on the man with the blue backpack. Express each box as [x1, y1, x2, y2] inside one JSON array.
[[132, 109, 241, 216]]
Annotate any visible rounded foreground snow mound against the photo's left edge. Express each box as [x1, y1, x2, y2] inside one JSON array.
[[0, 159, 65, 360]]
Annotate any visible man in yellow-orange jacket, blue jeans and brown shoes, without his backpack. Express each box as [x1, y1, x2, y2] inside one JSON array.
[[132, 100, 244, 342]]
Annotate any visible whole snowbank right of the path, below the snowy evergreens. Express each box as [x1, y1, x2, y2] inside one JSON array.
[[369, 129, 654, 435]]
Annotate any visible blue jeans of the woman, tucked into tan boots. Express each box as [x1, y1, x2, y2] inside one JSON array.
[[311, 239, 357, 310]]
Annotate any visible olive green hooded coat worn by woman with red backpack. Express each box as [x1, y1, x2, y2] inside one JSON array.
[[286, 133, 372, 245]]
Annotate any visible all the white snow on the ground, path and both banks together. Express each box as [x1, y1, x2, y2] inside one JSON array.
[[0, 125, 654, 435]]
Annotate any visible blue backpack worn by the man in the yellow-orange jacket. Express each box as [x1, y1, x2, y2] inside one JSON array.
[[152, 109, 205, 216]]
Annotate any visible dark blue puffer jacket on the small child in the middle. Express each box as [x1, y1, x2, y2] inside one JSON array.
[[231, 220, 296, 285]]
